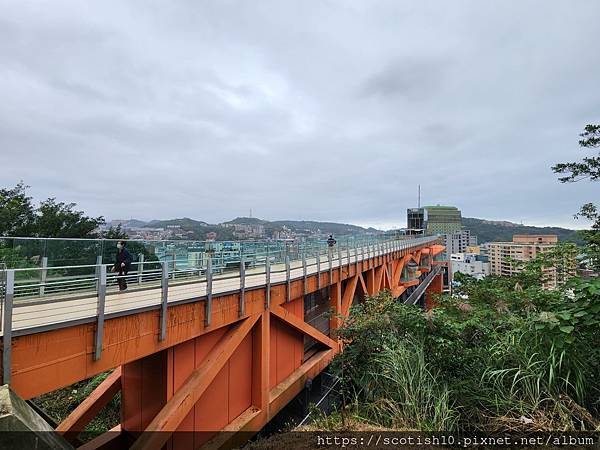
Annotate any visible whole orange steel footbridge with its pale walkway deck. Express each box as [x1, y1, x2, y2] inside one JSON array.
[[2, 237, 447, 449]]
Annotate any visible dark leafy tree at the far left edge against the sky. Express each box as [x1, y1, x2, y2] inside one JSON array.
[[0, 181, 35, 236]]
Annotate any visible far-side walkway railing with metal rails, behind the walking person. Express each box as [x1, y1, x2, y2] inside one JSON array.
[[0, 234, 433, 303]]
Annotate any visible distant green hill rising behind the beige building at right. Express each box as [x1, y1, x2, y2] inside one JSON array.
[[462, 217, 582, 244]]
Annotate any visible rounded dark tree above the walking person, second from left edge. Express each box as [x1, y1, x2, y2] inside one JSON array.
[[35, 198, 104, 238]]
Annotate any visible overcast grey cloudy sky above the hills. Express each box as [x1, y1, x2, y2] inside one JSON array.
[[0, 0, 600, 227]]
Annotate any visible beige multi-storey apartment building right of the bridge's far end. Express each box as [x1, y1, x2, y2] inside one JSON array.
[[488, 234, 575, 289]]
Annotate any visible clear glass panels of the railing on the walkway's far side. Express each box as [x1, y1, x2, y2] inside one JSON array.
[[0, 232, 434, 302]]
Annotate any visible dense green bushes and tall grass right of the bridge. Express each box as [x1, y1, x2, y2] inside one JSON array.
[[332, 253, 600, 432]]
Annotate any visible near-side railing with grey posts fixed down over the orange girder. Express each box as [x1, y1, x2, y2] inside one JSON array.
[[0, 237, 437, 382]]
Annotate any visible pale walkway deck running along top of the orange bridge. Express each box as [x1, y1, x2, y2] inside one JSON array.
[[0, 237, 435, 335]]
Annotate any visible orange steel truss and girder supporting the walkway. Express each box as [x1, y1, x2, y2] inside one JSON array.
[[0, 244, 443, 449]]
